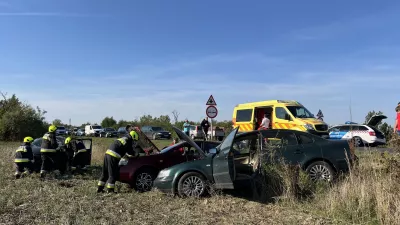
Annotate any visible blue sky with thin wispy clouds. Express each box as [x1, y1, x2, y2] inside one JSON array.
[[0, 0, 400, 125]]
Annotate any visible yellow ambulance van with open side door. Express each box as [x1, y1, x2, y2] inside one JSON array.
[[232, 100, 329, 138]]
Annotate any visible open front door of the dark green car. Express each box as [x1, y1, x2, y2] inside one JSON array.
[[212, 127, 239, 189]]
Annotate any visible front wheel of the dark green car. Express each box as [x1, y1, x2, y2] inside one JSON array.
[[178, 172, 206, 198]]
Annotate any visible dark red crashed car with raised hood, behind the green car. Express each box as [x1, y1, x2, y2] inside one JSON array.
[[119, 129, 220, 192]]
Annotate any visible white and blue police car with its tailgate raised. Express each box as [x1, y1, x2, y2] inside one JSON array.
[[328, 115, 387, 147]]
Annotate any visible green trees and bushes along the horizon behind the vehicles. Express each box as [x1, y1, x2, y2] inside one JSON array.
[[0, 92, 393, 141]]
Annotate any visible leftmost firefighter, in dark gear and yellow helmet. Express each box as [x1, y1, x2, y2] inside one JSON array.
[[14, 137, 33, 179]]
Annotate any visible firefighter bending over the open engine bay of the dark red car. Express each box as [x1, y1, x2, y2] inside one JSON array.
[[97, 131, 139, 193]]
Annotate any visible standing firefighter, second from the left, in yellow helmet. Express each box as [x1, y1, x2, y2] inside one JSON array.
[[40, 125, 58, 178]]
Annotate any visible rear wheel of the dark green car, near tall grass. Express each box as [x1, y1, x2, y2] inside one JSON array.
[[306, 161, 334, 182]]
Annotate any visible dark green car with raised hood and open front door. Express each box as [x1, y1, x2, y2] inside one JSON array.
[[154, 127, 356, 197]]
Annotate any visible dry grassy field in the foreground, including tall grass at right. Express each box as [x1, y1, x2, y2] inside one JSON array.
[[0, 138, 400, 225]]
